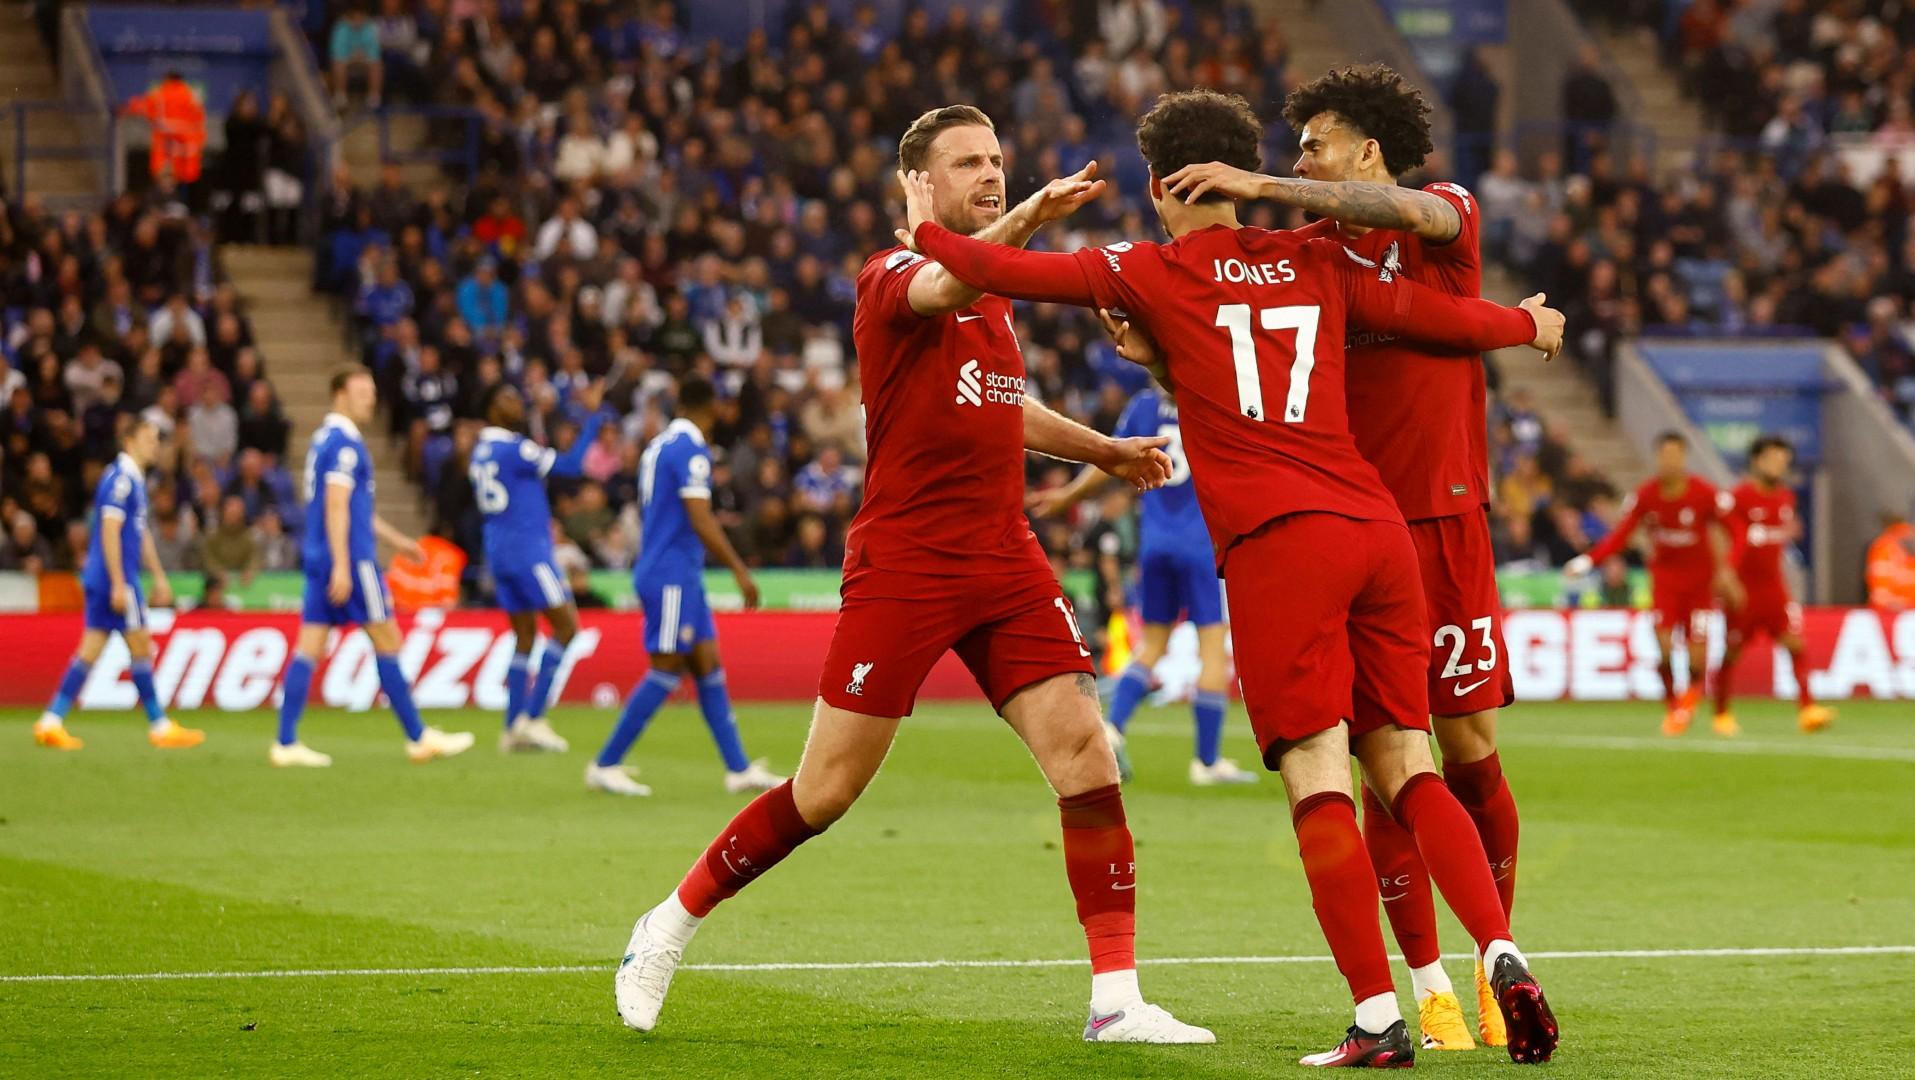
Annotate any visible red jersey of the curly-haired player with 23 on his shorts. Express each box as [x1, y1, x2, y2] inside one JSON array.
[[1296, 184, 1490, 521]]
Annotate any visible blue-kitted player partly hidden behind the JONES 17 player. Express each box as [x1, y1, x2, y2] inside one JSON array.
[[1030, 387, 1256, 787]]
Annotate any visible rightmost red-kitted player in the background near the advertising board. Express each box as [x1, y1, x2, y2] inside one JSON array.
[[1716, 435, 1835, 731]]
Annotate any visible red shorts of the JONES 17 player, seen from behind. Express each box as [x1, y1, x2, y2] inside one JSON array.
[[1224, 513, 1431, 770]]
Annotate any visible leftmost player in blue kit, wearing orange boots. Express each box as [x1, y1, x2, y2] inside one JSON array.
[[33, 417, 205, 751]]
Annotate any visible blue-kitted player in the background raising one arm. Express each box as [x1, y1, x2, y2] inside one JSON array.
[[467, 383, 605, 753]]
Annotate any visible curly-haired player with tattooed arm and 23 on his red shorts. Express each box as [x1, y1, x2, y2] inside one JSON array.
[[1164, 65, 1519, 1049]]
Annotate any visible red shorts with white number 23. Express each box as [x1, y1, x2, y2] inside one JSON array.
[[1409, 509, 1517, 716]]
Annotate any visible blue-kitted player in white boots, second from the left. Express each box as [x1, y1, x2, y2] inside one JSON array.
[[270, 368, 473, 768]]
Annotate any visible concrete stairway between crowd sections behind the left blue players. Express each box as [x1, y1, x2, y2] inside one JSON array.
[[220, 245, 427, 536]]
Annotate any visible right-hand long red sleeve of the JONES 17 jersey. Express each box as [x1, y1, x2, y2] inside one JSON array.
[[1310, 239, 1536, 352]]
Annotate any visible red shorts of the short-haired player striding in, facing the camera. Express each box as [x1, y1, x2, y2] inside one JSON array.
[[818, 559, 1095, 716]]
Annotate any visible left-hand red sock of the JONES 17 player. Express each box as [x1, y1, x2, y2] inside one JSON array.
[[1291, 791, 1394, 1001]]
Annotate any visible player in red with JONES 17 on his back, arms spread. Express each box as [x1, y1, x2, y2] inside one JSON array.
[[912, 90, 1563, 1067]]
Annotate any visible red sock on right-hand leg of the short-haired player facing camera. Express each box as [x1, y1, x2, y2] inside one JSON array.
[[1057, 783, 1138, 975]]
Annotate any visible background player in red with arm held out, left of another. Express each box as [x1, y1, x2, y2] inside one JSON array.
[[1563, 431, 1743, 737]]
